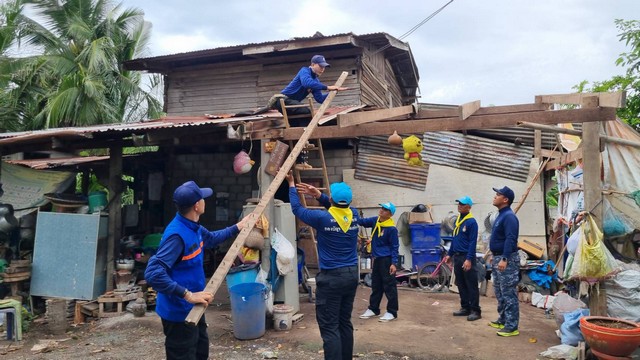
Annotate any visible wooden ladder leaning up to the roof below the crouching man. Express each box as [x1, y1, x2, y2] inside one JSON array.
[[280, 97, 331, 268]]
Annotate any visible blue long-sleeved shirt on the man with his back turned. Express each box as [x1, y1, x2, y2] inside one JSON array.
[[289, 187, 358, 270]]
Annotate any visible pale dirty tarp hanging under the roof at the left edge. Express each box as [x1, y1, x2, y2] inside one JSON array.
[[0, 162, 75, 218]]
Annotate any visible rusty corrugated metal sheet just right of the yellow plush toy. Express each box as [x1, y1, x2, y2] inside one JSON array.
[[423, 131, 533, 181]]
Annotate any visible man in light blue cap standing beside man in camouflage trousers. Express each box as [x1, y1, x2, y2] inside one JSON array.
[[445, 196, 482, 321]]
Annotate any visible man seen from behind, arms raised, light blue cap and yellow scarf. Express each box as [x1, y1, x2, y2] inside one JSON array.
[[287, 172, 360, 360]]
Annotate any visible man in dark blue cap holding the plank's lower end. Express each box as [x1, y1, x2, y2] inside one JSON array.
[[144, 181, 247, 360]]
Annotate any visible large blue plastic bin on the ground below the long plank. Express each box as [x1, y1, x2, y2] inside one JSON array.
[[229, 282, 267, 340]]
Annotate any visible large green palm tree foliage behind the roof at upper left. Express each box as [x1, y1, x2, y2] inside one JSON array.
[[0, 0, 162, 131]]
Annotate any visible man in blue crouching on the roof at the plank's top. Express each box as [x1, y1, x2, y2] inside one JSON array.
[[273, 55, 348, 127]]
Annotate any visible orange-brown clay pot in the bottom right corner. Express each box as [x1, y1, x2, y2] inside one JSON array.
[[580, 316, 640, 357]]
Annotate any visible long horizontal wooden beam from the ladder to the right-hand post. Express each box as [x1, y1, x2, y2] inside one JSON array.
[[264, 108, 616, 140]]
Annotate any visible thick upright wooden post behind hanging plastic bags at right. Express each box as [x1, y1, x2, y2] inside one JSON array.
[[582, 97, 607, 316]]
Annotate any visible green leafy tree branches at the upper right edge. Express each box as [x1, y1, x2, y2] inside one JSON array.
[[574, 19, 640, 131]]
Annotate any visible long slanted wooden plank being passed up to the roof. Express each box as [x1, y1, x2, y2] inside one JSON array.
[[185, 72, 348, 325]]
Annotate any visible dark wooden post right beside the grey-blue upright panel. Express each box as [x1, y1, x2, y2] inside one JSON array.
[[107, 146, 122, 291]]
